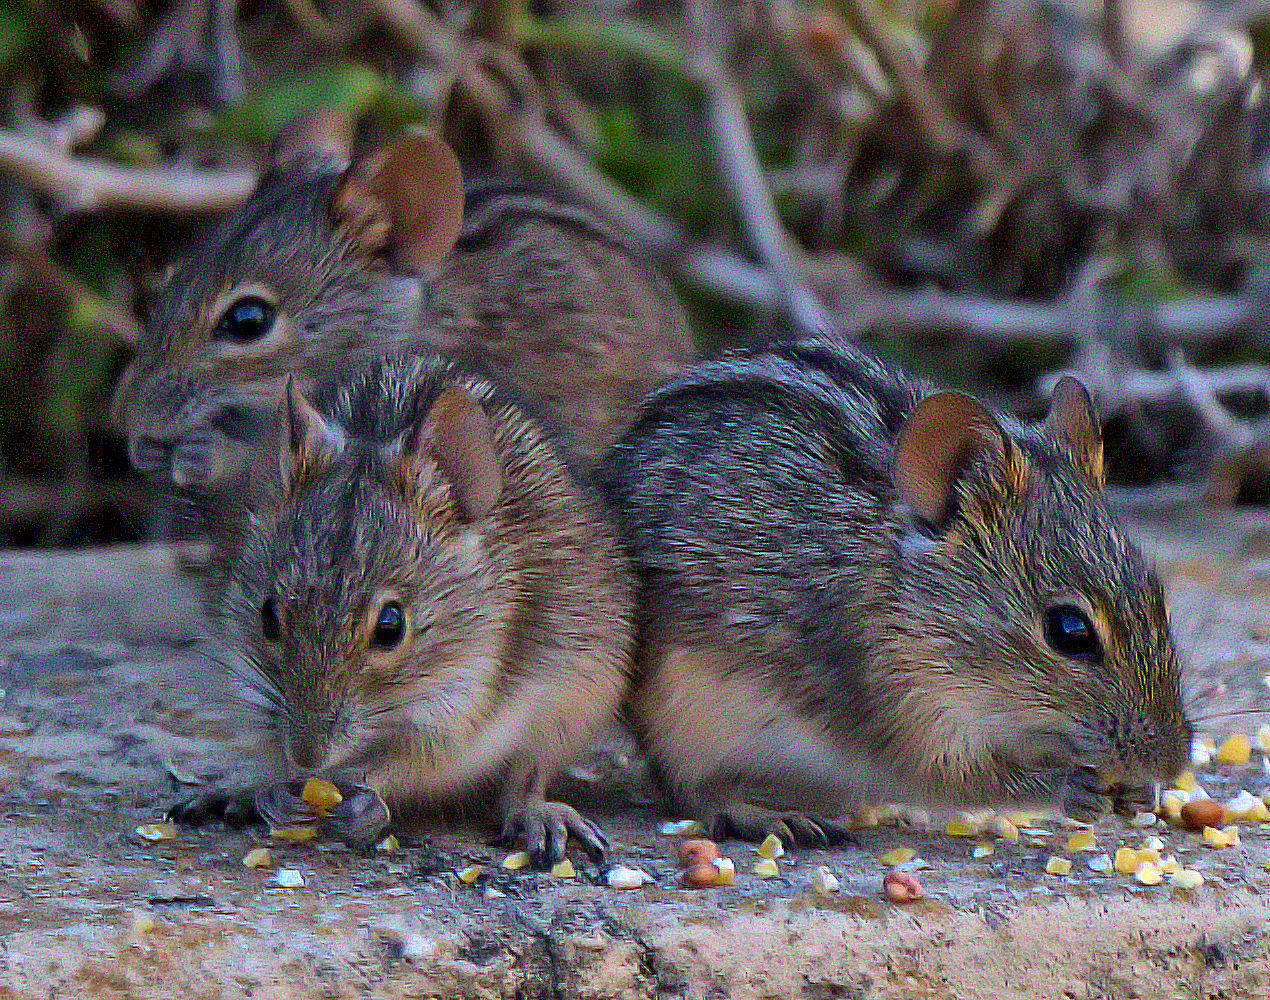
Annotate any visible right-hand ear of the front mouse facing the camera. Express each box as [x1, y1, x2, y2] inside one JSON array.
[[400, 386, 503, 522]]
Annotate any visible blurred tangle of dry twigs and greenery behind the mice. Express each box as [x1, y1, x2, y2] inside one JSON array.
[[0, 0, 1270, 545]]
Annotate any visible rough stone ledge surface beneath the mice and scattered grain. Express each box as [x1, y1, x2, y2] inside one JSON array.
[[0, 511, 1270, 1000]]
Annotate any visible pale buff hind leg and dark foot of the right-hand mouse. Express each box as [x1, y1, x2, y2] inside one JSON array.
[[631, 640, 851, 848]]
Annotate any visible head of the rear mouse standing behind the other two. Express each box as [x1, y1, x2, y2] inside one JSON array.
[[113, 112, 464, 489]]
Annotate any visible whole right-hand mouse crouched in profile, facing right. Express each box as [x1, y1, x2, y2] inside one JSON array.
[[601, 338, 1190, 841]]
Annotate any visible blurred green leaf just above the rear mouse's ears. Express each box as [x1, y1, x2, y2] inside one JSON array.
[[207, 62, 428, 141]]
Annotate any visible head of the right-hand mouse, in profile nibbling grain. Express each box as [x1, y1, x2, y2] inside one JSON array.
[[886, 379, 1191, 799]]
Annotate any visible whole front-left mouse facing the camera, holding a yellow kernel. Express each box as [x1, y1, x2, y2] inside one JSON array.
[[213, 357, 632, 856]]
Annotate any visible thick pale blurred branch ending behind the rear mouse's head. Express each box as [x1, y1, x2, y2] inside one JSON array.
[[0, 131, 257, 212]]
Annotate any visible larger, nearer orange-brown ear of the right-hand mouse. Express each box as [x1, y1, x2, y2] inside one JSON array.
[[892, 393, 1021, 527]]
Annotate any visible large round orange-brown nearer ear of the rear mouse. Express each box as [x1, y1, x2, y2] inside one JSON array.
[[333, 130, 464, 274]]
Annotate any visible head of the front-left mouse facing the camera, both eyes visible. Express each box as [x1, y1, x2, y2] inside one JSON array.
[[225, 358, 503, 781]]
